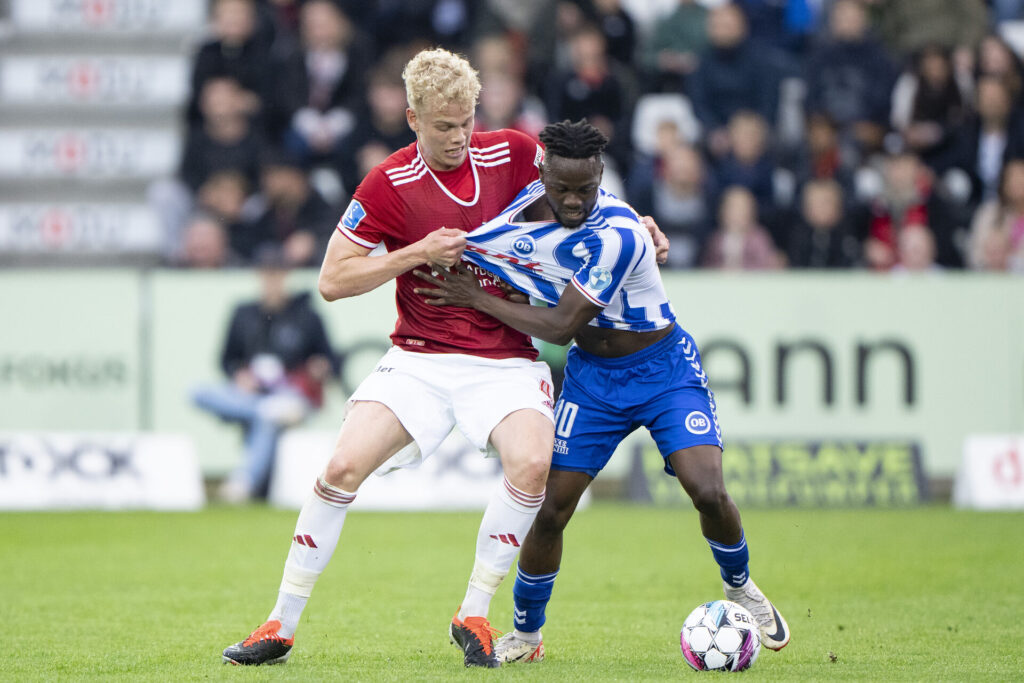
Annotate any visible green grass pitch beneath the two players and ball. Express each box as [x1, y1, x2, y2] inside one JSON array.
[[0, 504, 1024, 681]]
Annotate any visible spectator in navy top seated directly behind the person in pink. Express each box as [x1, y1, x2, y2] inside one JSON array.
[[714, 110, 775, 220]]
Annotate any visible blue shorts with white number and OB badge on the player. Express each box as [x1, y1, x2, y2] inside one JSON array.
[[551, 326, 722, 477]]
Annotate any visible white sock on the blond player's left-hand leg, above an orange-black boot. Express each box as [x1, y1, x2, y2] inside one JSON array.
[[267, 477, 355, 638]]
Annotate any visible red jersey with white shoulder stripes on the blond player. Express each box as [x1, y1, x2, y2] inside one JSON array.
[[338, 130, 544, 360]]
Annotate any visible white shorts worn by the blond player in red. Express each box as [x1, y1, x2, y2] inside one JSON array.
[[348, 346, 555, 473]]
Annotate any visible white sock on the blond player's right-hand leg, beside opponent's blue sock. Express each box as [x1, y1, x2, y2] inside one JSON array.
[[459, 478, 544, 618]]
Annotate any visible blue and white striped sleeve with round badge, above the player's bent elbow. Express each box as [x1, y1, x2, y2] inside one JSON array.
[[572, 227, 647, 308]]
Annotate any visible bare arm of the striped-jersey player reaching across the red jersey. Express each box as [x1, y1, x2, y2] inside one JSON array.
[[413, 263, 601, 345]]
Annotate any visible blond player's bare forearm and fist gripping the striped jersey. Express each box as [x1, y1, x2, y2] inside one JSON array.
[[317, 227, 466, 301]]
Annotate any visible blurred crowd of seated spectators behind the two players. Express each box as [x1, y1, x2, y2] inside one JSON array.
[[151, 0, 1024, 271]]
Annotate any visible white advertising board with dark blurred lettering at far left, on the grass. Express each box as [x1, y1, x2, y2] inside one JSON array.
[[0, 432, 206, 510]]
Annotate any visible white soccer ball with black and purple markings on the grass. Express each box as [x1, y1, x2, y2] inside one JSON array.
[[679, 600, 761, 671]]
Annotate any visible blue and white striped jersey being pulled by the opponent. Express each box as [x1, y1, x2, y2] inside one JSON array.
[[463, 180, 676, 332]]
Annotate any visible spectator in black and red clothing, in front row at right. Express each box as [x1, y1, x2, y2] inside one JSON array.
[[864, 151, 964, 270]]
